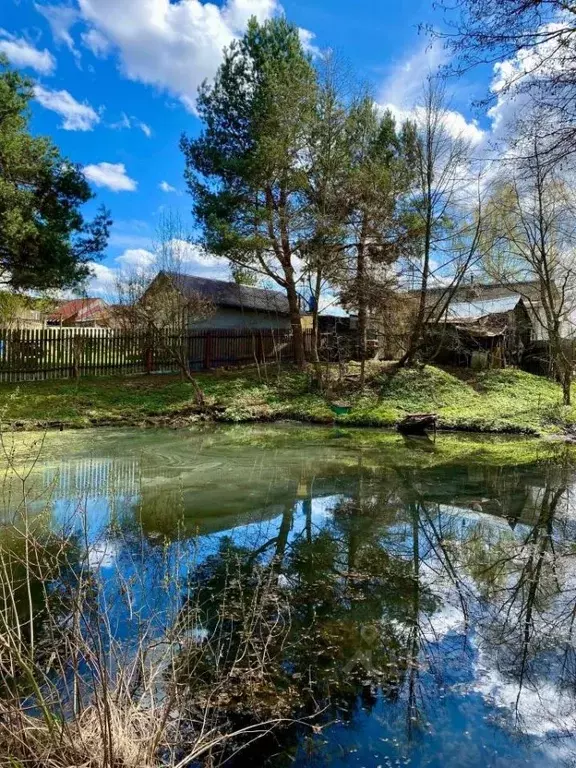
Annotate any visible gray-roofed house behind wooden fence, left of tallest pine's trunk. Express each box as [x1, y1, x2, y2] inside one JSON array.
[[146, 272, 290, 330]]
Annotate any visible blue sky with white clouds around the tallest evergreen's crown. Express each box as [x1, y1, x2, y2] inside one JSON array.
[[0, 0, 496, 294]]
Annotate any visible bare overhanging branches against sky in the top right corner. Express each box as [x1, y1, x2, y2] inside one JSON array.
[[429, 0, 576, 162]]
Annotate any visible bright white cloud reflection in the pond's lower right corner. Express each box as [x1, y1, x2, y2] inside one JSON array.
[[420, 505, 576, 765]]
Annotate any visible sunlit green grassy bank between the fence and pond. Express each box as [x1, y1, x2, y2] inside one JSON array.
[[0, 366, 576, 435]]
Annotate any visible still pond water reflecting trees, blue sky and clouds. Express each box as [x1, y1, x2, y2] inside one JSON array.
[[0, 426, 576, 768]]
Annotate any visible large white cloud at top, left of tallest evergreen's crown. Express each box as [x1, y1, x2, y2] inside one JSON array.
[[78, 0, 280, 110]]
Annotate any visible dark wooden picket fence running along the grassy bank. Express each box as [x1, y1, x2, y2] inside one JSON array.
[[0, 328, 302, 382]]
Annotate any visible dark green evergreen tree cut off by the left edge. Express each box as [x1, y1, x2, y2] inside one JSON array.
[[0, 57, 111, 289]]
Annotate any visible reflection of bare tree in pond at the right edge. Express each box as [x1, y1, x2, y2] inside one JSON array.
[[462, 468, 576, 730]]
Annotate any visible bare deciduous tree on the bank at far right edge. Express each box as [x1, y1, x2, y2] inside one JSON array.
[[485, 131, 576, 405]]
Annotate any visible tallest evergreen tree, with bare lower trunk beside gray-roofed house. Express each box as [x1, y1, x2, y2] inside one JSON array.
[[181, 18, 317, 365]]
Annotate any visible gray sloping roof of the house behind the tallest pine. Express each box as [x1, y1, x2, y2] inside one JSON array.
[[166, 272, 290, 315]]
